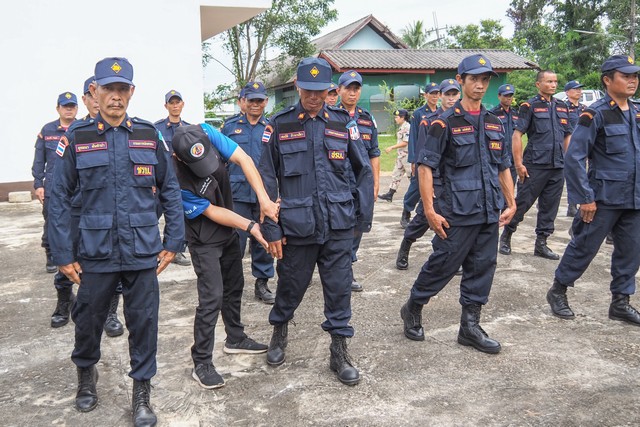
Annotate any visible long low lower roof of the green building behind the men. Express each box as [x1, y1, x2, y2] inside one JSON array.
[[318, 49, 538, 74]]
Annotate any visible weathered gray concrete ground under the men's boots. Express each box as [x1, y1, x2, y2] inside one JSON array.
[[0, 177, 640, 426]]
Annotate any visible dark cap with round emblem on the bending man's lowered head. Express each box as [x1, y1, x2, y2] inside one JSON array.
[[171, 125, 219, 178]]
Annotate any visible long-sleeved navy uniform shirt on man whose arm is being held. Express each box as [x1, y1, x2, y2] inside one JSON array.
[[258, 102, 373, 244]]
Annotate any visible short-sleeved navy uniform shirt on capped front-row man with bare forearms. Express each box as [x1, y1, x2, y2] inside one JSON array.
[[418, 101, 511, 226]]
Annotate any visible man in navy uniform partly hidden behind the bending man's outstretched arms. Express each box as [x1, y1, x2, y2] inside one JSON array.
[[222, 82, 276, 304]]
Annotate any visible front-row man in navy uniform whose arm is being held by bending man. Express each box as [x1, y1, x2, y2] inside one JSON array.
[[258, 58, 374, 385]]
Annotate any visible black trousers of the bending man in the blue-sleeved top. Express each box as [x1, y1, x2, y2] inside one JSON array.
[[189, 233, 246, 365]]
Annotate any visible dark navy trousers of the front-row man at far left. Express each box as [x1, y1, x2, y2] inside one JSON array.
[[71, 268, 160, 381]]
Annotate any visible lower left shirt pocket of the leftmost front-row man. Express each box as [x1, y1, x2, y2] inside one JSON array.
[[78, 215, 113, 259]]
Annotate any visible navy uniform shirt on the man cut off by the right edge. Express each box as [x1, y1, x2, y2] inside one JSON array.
[[564, 95, 640, 209]]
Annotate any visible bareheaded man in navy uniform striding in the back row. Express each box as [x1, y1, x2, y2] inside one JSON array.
[[500, 70, 572, 260]]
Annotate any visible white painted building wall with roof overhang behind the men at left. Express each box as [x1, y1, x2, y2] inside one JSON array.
[[0, 0, 271, 182]]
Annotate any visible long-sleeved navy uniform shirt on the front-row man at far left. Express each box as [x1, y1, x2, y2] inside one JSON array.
[[49, 114, 185, 273]]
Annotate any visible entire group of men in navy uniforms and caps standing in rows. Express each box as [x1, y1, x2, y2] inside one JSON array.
[[33, 51, 640, 425]]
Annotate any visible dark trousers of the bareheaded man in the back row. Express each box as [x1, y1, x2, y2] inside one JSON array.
[[506, 165, 564, 237]]
